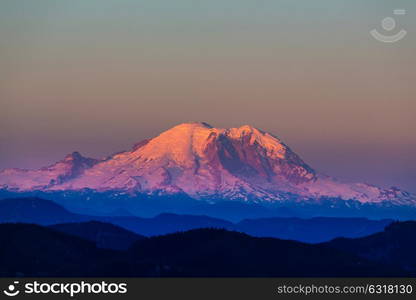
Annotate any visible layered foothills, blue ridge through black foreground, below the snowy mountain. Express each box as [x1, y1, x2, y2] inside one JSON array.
[[0, 198, 416, 277]]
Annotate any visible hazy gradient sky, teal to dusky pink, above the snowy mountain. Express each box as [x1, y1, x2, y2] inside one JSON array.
[[0, 0, 416, 192]]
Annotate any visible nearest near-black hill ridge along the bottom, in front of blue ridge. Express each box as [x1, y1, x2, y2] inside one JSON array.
[[0, 222, 416, 277]]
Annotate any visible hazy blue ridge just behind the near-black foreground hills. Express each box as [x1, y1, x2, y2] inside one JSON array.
[[0, 198, 393, 244]]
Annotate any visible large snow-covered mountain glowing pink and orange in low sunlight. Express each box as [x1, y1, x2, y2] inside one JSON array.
[[0, 122, 416, 206]]
